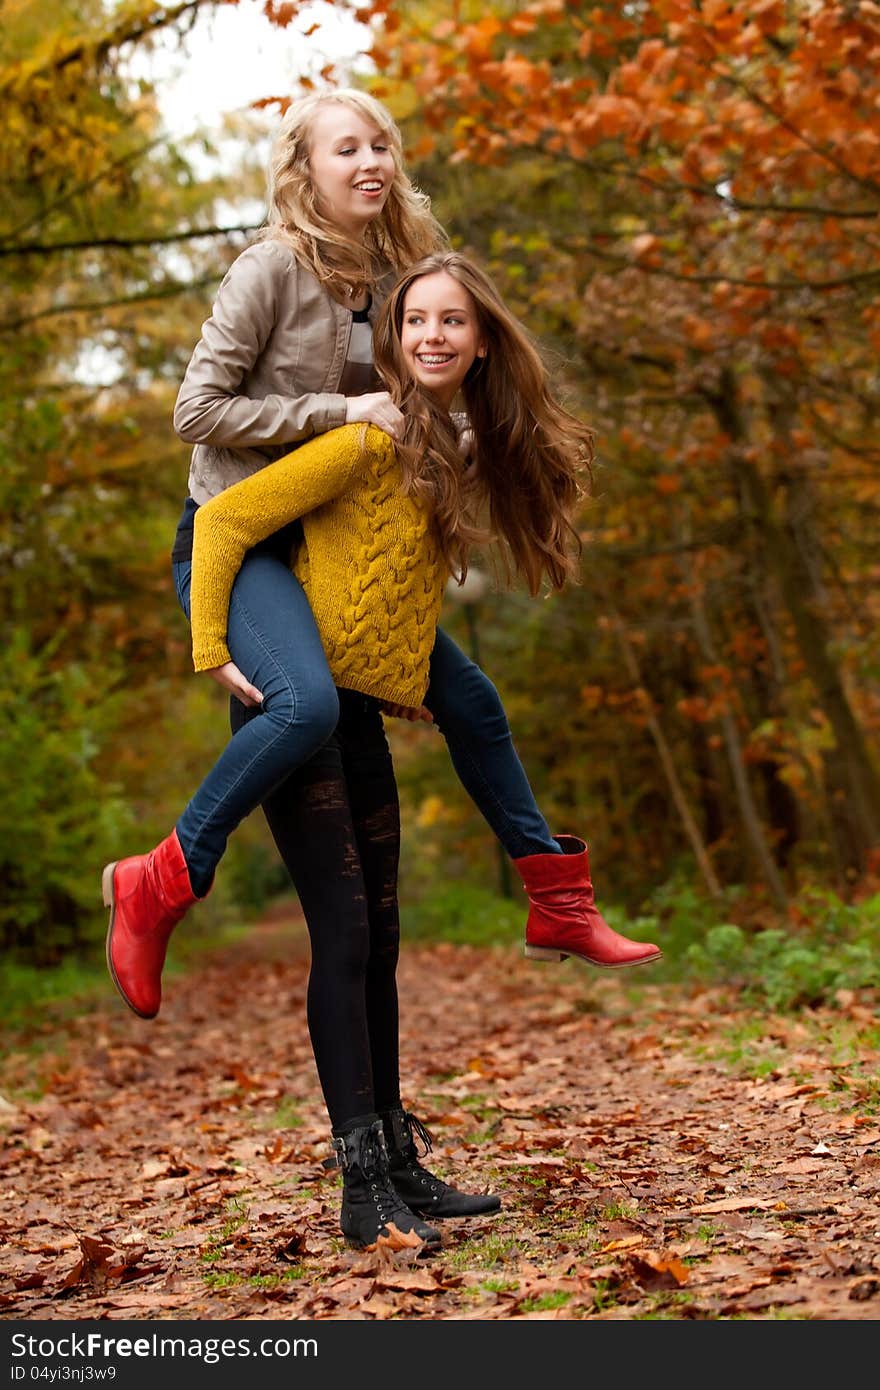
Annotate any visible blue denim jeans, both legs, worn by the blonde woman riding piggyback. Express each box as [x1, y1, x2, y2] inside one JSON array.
[[172, 550, 560, 895]]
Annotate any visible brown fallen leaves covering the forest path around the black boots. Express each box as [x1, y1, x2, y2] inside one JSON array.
[[0, 926, 880, 1321]]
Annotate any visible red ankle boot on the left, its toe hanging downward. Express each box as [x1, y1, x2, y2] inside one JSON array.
[[101, 830, 199, 1019]]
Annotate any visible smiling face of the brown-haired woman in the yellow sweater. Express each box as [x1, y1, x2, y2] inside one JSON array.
[[400, 270, 485, 410]]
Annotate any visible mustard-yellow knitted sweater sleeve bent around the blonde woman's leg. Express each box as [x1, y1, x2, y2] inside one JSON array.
[[190, 425, 380, 671]]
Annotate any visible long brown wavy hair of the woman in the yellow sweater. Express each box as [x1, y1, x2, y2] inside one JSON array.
[[373, 250, 594, 595]]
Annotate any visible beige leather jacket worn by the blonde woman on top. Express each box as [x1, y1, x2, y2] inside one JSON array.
[[174, 240, 393, 503]]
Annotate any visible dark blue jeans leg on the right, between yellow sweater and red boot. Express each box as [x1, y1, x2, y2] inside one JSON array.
[[425, 628, 560, 859]]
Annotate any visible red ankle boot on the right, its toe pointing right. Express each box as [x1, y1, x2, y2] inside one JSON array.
[[513, 835, 663, 970]]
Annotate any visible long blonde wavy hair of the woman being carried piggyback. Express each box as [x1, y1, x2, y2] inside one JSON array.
[[259, 88, 448, 296]]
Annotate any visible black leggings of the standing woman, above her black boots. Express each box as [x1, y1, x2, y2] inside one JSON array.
[[232, 689, 400, 1129]]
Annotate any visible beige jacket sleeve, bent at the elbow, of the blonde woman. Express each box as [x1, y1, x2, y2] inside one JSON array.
[[174, 242, 345, 448]]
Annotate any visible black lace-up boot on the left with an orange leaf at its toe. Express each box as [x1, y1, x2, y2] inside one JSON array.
[[331, 1115, 441, 1250]]
